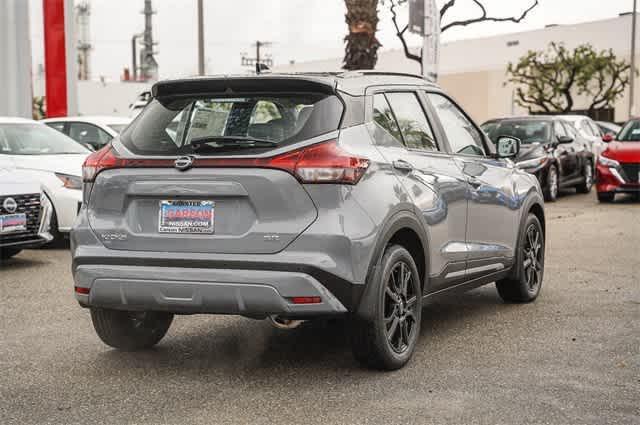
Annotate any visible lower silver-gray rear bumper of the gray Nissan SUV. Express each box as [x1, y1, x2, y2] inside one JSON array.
[[74, 264, 347, 317]]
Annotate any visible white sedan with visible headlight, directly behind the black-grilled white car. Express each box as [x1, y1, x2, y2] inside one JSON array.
[[0, 117, 91, 237]]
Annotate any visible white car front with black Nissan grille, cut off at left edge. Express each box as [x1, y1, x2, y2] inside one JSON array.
[[0, 168, 53, 261]]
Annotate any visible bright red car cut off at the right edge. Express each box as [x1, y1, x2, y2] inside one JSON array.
[[596, 119, 640, 202]]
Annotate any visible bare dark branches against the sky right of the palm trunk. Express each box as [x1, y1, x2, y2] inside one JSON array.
[[386, 0, 538, 70]]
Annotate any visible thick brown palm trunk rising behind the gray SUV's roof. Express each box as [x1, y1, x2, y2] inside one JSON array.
[[343, 0, 381, 69]]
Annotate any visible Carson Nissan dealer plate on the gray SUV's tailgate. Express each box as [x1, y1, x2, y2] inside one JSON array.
[[158, 200, 215, 234]]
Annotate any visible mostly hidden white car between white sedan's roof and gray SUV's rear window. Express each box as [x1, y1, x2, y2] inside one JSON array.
[[42, 116, 131, 150]]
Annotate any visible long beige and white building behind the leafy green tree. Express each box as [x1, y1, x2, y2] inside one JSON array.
[[276, 14, 640, 122]]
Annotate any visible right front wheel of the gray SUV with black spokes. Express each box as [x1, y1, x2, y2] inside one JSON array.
[[496, 214, 545, 303]]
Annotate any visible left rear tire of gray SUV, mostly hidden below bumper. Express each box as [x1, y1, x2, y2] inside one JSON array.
[[91, 308, 173, 351]]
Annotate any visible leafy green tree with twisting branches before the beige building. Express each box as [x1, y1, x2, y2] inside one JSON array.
[[507, 43, 631, 113]]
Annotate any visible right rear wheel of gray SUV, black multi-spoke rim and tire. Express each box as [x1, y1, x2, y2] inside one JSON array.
[[351, 245, 422, 370]]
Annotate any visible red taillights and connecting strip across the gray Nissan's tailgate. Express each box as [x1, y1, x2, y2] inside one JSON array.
[[82, 140, 369, 184]]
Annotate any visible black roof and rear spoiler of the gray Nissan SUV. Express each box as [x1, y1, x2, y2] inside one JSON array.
[[151, 71, 437, 97]]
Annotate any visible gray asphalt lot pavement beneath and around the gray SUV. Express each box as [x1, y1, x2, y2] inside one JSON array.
[[0, 194, 640, 425]]
